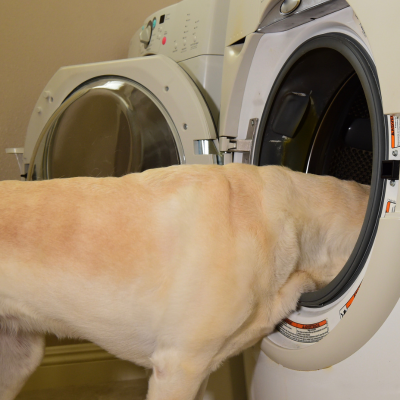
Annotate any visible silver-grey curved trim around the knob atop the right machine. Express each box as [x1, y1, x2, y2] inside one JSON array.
[[257, 0, 349, 33]]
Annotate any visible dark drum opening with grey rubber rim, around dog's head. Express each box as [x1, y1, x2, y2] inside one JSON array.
[[253, 33, 386, 307]]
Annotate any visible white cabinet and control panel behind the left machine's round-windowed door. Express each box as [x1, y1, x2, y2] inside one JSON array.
[[128, 0, 230, 126]]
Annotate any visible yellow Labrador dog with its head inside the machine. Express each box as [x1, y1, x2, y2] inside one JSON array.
[[0, 164, 369, 400]]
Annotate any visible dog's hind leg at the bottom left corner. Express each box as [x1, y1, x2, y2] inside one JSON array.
[[0, 328, 44, 400]]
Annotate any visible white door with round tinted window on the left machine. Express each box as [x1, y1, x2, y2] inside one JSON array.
[[24, 56, 217, 180]]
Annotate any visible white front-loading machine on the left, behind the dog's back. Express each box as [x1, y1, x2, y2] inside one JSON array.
[[13, 0, 229, 180]]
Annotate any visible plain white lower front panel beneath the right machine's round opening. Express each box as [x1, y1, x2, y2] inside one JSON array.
[[246, 290, 400, 400]]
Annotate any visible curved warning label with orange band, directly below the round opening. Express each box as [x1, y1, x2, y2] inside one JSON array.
[[277, 318, 329, 343]]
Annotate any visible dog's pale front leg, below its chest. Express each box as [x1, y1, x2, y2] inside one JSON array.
[[147, 350, 210, 400]]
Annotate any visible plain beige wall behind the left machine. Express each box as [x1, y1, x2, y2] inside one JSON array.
[[0, 0, 178, 180]]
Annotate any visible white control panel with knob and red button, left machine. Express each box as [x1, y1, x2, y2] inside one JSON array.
[[128, 0, 229, 62]]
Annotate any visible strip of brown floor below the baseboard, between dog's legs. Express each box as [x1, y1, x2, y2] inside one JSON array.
[[16, 379, 147, 400]]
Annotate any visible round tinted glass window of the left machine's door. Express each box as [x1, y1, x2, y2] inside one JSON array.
[[28, 77, 184, 180]]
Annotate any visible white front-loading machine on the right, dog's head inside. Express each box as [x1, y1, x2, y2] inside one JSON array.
[[216, 0, 400, 400]]
